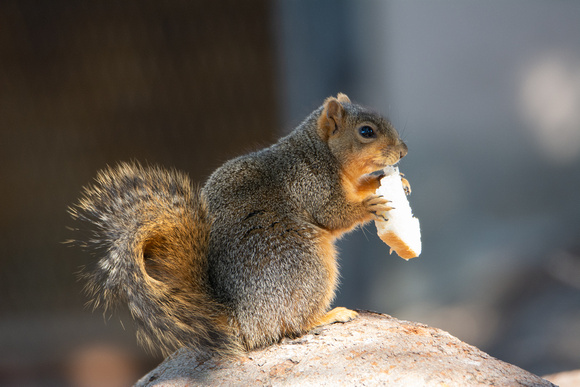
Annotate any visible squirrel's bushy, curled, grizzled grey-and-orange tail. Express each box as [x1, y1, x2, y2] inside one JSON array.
[[69, 163, 238, 355]]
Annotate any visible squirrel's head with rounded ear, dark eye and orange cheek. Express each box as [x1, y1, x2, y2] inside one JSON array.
[[317, 93, 407, 176]]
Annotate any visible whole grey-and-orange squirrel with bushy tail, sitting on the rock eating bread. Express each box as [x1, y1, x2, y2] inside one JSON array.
[[69, 93, 407, 356]]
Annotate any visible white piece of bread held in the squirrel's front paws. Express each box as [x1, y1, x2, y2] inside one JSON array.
[[375, 166, 421, 259]]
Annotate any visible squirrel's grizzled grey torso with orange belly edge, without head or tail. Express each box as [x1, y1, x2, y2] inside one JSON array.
[[203, 117, 340, 349]]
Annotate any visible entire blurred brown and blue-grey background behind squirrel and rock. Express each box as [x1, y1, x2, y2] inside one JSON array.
[[0, 0, 580, 386]]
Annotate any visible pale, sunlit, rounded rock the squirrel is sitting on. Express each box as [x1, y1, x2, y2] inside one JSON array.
[[136, 312, 552, 387]]
